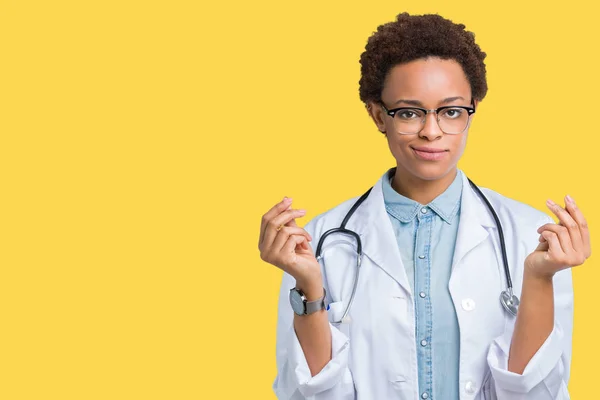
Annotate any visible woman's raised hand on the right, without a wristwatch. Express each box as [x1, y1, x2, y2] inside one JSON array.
[[525, 196, 592, 278]]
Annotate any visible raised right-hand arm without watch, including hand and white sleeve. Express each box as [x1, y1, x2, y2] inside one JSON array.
[[488, 194, 591, 400]]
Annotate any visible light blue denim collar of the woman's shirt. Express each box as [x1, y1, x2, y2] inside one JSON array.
[[382, 168, 463, 224]]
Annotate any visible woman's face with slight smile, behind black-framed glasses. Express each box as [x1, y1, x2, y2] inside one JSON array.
[[369, 58, 477, 181]]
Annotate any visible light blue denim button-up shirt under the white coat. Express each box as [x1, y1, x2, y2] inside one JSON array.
[[383, 168, 463, 400]]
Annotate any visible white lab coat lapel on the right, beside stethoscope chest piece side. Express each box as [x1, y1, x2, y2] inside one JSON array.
[[452, 174, 495, 273]]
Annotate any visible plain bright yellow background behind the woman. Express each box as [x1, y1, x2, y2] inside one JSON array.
[[0, 0, 600, 400]]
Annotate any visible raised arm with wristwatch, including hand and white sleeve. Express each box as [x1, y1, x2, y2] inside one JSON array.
[[258, 199, 354, 400]]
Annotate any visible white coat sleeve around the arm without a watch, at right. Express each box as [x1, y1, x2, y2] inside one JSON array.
[[487, 216, 573, 400]]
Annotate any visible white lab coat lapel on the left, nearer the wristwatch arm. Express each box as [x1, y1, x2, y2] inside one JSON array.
[[348, 174, 411, 293]]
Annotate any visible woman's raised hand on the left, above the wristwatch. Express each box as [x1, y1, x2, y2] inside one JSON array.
[[258, 197, 323, 288]]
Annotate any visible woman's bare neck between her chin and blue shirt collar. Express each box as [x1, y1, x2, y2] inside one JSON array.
[[392, 168, 458, 205]]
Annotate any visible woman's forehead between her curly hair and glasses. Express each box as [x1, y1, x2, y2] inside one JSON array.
[[381, 58, 471, 103]]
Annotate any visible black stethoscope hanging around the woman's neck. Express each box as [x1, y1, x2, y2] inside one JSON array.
[[316, 178, 519, 323]]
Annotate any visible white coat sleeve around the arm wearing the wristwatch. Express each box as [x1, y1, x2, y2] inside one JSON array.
[[273, 221, 355, 400]]
